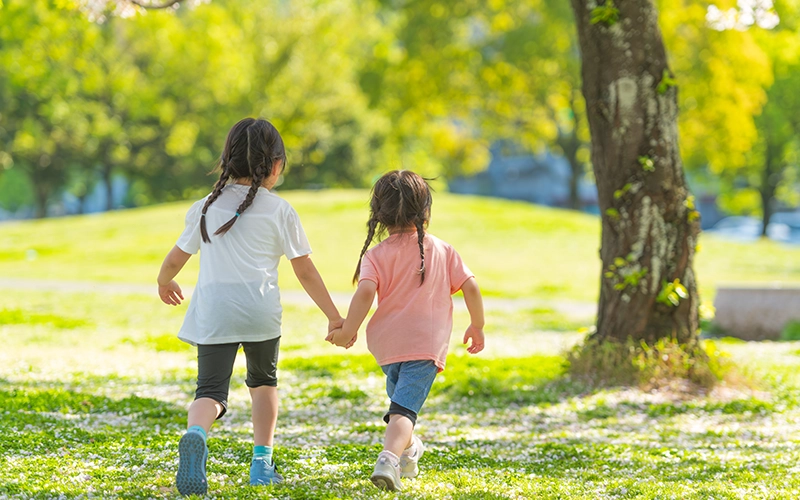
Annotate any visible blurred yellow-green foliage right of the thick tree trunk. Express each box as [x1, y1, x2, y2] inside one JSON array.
[[659, 0, 800, 222]]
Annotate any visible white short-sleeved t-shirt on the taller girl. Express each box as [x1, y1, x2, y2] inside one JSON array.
[[177, 184, 311, 345]]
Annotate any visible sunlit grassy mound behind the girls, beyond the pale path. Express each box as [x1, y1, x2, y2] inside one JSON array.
[[0, 190, 800, 301]]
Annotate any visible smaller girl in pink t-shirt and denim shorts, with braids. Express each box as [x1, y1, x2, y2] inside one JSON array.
[[326, 170, 484, 490]]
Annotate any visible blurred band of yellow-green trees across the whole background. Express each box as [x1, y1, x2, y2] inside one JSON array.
[[0, 0, 800, 218]]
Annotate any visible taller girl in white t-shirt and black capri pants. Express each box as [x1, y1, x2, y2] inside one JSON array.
[[158, 118, 343, 495]]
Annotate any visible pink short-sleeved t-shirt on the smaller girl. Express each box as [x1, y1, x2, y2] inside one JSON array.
[[359, 232, 474, 371]]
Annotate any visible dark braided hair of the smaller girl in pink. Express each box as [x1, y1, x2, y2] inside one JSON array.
[[353, 170, 433, 285]]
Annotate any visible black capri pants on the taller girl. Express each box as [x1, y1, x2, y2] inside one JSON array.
[[194, 337, 281, 419]]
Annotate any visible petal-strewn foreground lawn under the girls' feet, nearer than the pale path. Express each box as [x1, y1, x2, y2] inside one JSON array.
[[0, 291, 800, 499]]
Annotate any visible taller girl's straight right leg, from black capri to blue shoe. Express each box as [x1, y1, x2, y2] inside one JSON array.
[[244, 338, 283, 485]]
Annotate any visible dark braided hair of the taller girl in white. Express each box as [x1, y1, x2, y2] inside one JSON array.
[[200, 118, 286, 243]]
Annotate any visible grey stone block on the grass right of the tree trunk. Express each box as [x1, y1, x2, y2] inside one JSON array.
[[714, 287, 800, 340]]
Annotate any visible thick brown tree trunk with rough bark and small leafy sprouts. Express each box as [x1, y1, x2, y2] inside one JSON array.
[[572, 0, 700, 343]]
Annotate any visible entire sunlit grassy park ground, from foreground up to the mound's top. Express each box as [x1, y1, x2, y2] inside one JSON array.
[[0, 191, 800, 499]]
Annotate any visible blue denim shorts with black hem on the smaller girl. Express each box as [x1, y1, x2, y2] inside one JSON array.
[[381, 360, 439, 424]]
